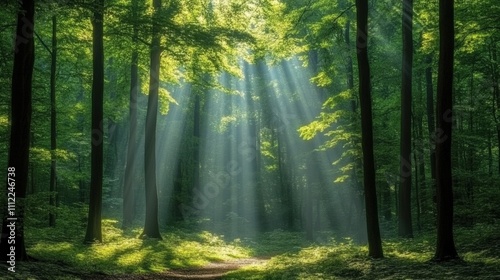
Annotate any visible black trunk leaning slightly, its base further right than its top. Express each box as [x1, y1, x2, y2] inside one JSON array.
[[356, 0, 384, 258]]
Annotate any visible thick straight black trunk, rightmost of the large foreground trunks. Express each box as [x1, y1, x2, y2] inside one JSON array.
[[434, 0, 458, 261]]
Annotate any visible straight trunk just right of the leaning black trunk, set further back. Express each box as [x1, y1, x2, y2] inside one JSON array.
[[398, 0, 413, 237]]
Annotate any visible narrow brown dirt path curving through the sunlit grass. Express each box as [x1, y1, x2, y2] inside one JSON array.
[[92, 258, 267, 280]]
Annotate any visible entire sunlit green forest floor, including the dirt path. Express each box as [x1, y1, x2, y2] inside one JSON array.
[[0, 211, 500, 280]]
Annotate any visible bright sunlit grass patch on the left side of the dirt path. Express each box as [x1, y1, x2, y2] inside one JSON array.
[[27, 219, 250, 274]]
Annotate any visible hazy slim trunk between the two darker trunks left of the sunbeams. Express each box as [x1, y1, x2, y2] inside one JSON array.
[[122, 0, 140, 228]]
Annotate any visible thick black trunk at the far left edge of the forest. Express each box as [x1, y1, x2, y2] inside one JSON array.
[[0, 0, 35, 262]]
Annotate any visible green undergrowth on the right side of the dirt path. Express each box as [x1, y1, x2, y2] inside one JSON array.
[[225, 225, 500, 279]]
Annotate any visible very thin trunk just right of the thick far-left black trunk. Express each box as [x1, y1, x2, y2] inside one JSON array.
[[49, 15, 57, 227]]
